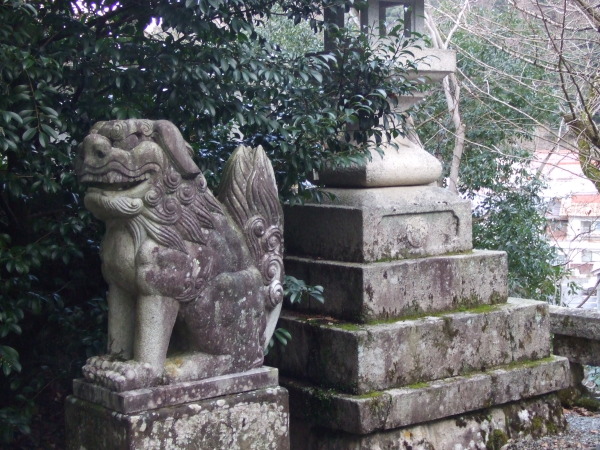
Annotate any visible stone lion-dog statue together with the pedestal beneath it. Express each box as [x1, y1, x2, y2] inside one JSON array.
[[67, 120, 289, 449]]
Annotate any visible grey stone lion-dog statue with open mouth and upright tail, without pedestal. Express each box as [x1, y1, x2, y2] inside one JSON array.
[[76, 120, 283, 391]]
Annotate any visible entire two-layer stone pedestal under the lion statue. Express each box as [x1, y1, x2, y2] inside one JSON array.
[[66, 368, 289, 450]]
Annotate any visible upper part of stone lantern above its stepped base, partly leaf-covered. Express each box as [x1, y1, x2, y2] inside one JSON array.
[[319, 0, 456, 187]]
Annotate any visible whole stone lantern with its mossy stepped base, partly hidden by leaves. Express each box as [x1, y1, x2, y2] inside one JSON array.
[[269, 1, 569, 450]]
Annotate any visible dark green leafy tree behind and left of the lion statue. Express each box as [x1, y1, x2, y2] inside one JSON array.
[[0, 0, 420, 446]]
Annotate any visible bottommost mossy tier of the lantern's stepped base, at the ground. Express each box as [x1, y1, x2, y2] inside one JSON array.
[[290, 395, 567, 450]]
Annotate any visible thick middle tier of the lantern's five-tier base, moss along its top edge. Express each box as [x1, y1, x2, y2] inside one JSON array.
[[267, 299, 550, 394]]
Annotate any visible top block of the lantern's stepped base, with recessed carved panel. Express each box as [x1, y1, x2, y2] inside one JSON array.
[[284, 186, 473, 262]]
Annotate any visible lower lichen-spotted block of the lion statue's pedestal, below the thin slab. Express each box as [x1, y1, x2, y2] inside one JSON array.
[[66, 387, 289, 450]]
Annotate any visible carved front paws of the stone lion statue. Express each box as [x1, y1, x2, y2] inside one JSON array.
[[82, 355, 162, 392]]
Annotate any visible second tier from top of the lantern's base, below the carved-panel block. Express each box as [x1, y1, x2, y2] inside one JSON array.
[[285, 250, 508, 323]]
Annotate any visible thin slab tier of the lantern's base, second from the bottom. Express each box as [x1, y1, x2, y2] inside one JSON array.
[[281, 356, 569, 435]]
